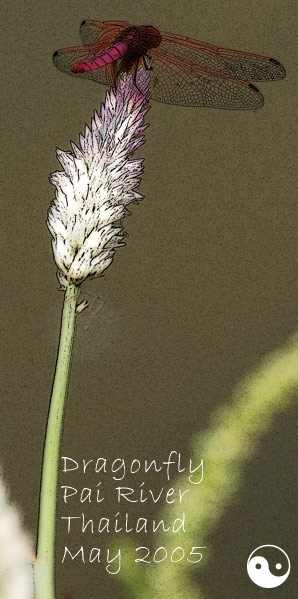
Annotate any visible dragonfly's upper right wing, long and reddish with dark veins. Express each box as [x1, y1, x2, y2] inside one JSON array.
[[159, 33, 286, 81]]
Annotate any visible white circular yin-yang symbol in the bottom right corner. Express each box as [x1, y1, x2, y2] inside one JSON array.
[[247, 545, 291, 589]]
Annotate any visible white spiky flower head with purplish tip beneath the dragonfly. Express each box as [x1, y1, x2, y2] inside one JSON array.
[[47, 68, 148, 289]]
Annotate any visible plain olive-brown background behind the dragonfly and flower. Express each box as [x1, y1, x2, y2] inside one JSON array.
[[0, 0, 298, 599]]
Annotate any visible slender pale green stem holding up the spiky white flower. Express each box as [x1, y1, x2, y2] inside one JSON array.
[[35, 284, 80, 599]]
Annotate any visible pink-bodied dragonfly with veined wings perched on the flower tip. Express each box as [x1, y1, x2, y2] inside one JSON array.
[[53, 20, 286, 110]]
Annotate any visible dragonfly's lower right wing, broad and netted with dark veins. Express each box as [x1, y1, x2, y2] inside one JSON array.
[[150, 48, 264, 110]]
